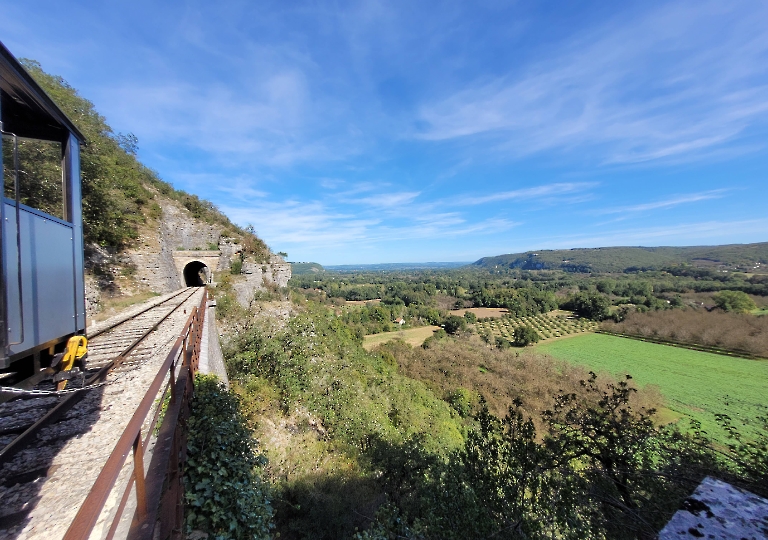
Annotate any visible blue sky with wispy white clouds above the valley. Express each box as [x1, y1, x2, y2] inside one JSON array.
[[0, 0, 768, 264]]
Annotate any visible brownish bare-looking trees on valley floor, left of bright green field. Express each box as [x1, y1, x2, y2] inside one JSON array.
[[380, 339, 663, 433]]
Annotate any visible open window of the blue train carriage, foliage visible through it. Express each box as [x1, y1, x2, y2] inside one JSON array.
[[3, 135, 64, 219]]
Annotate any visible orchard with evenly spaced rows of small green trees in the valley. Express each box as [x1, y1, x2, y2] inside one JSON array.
[[475, 311, 598, 342]]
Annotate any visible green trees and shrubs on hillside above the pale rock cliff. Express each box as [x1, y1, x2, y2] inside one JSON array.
[[21, 59, 269, 254]]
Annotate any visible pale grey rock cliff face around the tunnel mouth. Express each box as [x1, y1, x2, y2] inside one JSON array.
[[86, 200, 291, 316]]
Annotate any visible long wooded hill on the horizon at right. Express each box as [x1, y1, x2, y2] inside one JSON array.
[[473, 242, 768, 272]]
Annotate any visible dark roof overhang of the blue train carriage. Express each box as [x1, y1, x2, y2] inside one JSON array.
[[0, 42, 85, 142]]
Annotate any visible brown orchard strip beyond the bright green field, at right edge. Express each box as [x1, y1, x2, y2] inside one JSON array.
[[603, 310, 768, 356]]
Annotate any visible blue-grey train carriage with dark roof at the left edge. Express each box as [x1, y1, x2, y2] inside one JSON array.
[[0, 43, 86, 385]]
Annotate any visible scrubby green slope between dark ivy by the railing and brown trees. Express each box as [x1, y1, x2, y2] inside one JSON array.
[[219, 304, 463, 538]]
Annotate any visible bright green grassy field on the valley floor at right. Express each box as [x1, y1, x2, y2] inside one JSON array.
[[536, 334, 768, 442]]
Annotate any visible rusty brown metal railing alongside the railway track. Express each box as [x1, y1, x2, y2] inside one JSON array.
[[64, 290, 208, 540]]
